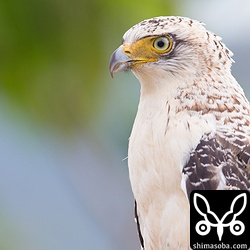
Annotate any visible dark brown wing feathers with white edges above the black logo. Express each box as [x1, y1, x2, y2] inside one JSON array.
[[183, 135, 250, 197]]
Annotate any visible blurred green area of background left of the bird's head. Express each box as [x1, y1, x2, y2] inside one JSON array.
[[0, 0, 176, 133]]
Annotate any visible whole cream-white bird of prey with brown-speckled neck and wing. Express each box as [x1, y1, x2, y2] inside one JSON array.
[[110, 16, 250, 250]]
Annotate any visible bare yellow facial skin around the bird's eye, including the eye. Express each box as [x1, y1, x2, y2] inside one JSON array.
[[121, 36, 173, 62]]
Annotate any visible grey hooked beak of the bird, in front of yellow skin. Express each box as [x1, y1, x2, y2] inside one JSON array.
[[109, 46, 134, 77]]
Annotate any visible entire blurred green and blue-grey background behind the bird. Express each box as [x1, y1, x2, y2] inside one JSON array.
[[0, 0, 250, 250]]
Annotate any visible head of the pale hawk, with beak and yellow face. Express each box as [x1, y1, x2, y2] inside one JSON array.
[[109, 16, 232, 80]]
